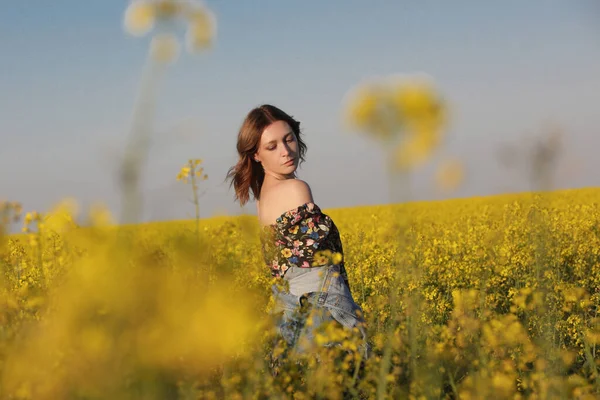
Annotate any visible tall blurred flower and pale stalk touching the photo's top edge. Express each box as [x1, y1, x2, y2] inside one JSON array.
[[120, 0, 216, 223]]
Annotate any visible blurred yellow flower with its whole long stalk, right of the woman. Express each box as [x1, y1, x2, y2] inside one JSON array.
[[344, 72, 446, 399]]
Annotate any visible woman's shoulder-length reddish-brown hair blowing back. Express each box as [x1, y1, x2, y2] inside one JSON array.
[[226, 104, 306, 206]]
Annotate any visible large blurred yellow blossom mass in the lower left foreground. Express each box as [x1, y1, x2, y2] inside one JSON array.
[[0, 239, 258, 399]]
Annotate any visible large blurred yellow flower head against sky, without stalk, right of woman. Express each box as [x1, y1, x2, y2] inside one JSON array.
[[344, 76, 446, 170]]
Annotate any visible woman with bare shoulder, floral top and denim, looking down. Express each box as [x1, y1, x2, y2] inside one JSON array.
[[227, 105, 368, 366]]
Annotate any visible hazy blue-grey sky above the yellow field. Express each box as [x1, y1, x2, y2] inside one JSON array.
[[0, 0, 600, 225]]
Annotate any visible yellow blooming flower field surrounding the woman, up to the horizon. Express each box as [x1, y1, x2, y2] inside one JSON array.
[[0, 189, 600, 399]]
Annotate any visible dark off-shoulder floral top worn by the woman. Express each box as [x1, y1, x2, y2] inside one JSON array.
[[261, 203, 348, 284]]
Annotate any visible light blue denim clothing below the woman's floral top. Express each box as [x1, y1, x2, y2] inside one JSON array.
[[272, 265, 369, 358]]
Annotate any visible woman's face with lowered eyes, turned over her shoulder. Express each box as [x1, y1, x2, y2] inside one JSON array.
[[254, 121, 298, 176]]
